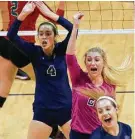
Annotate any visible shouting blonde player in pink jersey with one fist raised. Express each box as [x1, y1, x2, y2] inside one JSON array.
[[66, 12, 115, 139]]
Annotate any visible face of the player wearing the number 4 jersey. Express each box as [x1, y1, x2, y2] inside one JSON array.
[[38, 25, 55, 50]]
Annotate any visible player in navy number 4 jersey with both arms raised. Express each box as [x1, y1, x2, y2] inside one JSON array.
[[8, 1, 72, 139]]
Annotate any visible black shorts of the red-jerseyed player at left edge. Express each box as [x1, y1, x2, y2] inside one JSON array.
[[0, 37, 30, 68]]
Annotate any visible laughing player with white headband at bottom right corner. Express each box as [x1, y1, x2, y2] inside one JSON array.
[[89, 96, 132, 139]]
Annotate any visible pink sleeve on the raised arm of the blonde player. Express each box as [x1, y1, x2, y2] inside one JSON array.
[[66, 54, 83, 86]]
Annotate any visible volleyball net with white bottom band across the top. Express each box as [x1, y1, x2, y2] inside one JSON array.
[[0, 1, 135, 36]]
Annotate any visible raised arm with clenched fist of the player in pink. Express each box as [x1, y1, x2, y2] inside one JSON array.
[[66, 12, 83, 86]]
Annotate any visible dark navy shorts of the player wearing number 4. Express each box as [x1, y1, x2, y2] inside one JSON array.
[[33, 108, 71, 127]]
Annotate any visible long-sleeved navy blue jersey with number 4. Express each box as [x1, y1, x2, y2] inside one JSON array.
[[8, 17, 73, 109]]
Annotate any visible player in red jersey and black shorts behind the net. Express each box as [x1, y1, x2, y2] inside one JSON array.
[[0, 1, 64, 107]]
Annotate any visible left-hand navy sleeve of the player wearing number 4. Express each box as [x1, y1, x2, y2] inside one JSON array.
[[7, 19, 36, 55]]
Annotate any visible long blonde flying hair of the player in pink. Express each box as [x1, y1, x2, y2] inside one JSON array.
[[85, 47, 131, 86]]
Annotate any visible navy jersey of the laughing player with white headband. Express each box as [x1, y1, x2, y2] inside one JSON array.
[[89, 122, 132, 139]]
